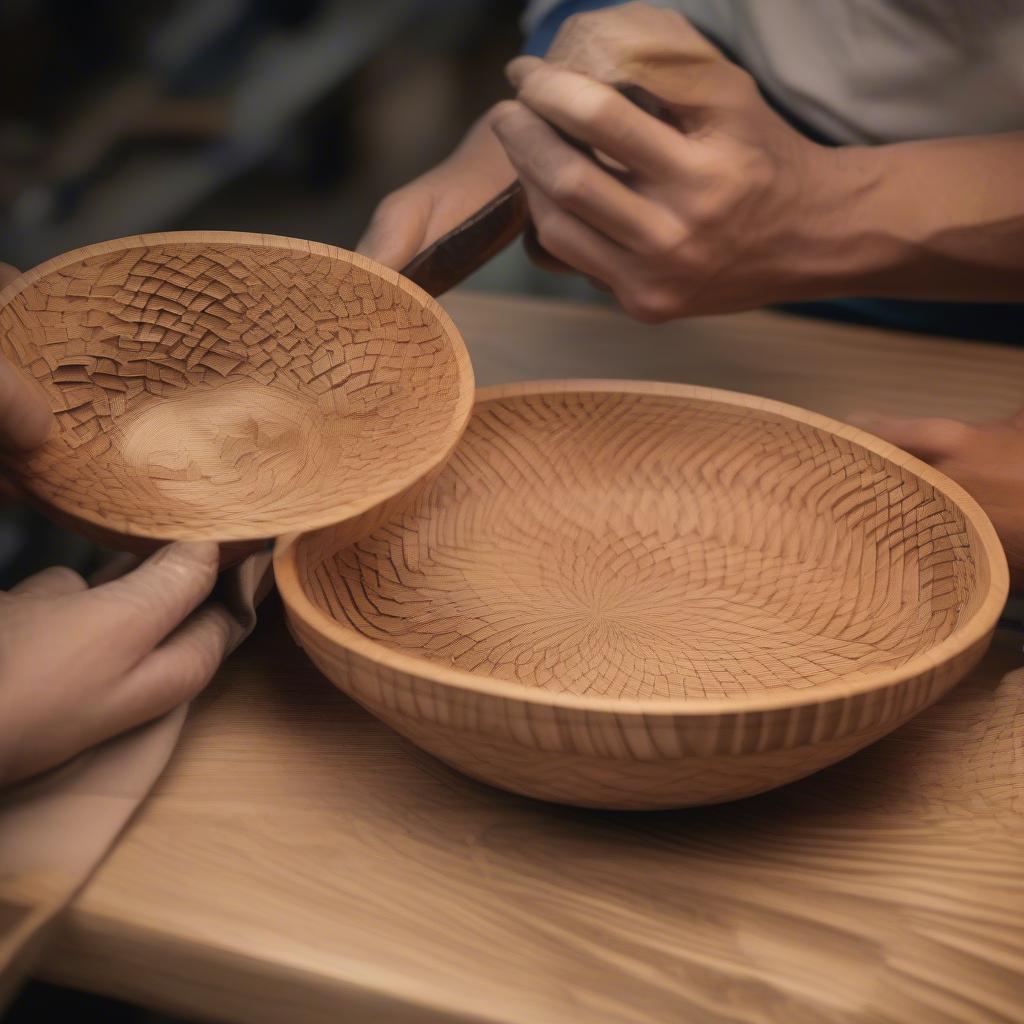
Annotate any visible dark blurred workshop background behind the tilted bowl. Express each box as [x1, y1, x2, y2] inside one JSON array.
[[0, 0, 600, 589]]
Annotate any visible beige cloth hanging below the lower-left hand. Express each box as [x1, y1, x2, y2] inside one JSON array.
[[0, 551, 272, 1012]]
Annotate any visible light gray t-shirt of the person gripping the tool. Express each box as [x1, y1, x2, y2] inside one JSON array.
[[524, 0, 1024, 143]]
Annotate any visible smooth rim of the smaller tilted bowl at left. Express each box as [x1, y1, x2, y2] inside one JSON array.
[[0, 231, 475, 544]]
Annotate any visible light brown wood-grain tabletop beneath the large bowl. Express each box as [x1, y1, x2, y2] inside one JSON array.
[[36, 295, 1024, 1024]]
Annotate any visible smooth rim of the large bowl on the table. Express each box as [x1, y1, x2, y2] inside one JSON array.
[[273, 378, 1010, 717]]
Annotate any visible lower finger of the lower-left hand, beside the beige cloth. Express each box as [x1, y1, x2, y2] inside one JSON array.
[[102, 604, 243, 735]]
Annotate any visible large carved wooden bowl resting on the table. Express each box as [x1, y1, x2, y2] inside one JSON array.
[[275, 381, 1008, 808]]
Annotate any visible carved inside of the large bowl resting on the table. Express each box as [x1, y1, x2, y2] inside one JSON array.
[[295, 391, 985, 699]]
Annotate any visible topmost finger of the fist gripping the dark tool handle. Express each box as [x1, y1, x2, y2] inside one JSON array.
[[509, 60, 690, 179]]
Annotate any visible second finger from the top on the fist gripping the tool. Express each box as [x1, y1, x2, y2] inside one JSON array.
[[494, 100, 682, 255]]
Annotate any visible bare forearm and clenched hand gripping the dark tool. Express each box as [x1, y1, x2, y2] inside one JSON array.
[[494, 4, 1024, 321]]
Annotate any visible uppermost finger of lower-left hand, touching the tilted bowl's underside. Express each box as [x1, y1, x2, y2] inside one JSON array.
[[61, 541, 219, 676]]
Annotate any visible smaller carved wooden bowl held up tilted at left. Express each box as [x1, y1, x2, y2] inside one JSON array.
[[0, 231, 473, 551]]
